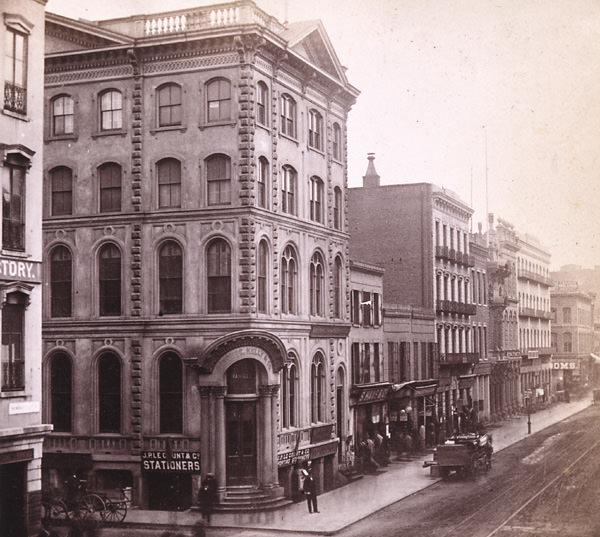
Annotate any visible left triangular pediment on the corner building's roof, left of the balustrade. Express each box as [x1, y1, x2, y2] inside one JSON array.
[[45, 13, 132, 54]]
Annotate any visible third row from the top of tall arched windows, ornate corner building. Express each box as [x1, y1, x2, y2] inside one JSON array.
[[49, 238, 345, 319]]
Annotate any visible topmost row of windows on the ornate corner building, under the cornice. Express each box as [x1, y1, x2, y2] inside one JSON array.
[[50, 78, 343, 161]]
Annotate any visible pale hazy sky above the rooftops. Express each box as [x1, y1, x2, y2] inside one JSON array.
[[46, 0, 600, 269]]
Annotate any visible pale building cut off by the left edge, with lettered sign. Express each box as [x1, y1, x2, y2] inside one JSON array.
[[0, 0, 51, 537]]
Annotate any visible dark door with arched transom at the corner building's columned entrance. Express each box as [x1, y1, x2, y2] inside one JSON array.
[[225, 358, 260, 486]]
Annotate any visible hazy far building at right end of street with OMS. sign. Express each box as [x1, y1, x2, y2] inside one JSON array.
[[551, 282, 600, 393]]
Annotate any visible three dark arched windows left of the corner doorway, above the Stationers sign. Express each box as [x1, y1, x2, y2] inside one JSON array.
[[49, 352, 183, 433]]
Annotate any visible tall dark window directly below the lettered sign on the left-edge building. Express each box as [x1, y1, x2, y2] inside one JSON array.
[[2, 303, 25, 391]]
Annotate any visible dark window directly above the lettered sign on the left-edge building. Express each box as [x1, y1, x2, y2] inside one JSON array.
[[2, 163, 25, 250]]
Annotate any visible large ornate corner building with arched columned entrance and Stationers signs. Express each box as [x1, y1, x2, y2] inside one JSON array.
[[43, 0, 358, 509]]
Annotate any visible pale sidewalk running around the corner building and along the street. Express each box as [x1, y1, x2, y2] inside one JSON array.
[[125, 395, 592, 535]]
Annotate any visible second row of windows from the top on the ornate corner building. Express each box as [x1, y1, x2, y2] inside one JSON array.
[[49, 153, 343, 229]]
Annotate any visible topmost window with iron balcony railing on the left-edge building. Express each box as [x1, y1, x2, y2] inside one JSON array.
[[4, 28, 27, 114]]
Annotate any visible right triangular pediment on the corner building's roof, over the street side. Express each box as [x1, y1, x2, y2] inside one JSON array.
[[282, 20, 347, 83]]
